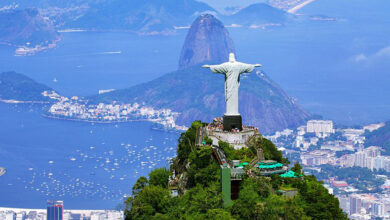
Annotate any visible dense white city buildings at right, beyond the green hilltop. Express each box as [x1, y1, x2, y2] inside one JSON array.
[[267, 120, 390, 220]]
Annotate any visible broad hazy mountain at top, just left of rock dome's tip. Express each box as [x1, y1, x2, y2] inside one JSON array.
[[67, 0, 215, 33]]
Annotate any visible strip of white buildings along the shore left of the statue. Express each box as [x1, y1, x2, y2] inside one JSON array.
[[43, 93, 187, 130]]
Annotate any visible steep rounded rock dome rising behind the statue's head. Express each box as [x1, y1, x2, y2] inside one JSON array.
[[179, 14, 234, 69]]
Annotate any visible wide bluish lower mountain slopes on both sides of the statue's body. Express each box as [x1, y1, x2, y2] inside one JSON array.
[[89, 65, 310, 133]]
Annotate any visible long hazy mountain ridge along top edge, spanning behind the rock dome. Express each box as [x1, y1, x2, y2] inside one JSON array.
[[0, 0, 289, 34]]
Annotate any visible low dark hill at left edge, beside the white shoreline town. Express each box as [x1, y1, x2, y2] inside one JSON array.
[[0, 72, 53, 101]]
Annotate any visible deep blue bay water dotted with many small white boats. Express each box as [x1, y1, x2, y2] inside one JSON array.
[[0, 103, 178, 209]]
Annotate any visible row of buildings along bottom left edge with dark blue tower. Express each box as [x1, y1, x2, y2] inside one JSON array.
[[0, 201, 124, 220]]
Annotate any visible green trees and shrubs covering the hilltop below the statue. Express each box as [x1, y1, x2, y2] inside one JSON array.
[[125, 121, 347, 220]]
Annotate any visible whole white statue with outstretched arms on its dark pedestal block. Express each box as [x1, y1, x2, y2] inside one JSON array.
[[203, 53, 261, 130]]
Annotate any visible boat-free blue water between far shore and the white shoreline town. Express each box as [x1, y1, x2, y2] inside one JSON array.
[[0, 32, 185, 96]]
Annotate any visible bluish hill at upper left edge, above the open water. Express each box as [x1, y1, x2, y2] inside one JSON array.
[[0, 8, 60, 46]]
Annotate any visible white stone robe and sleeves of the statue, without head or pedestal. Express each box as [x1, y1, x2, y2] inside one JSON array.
[[210, 61, 255, 115]]
